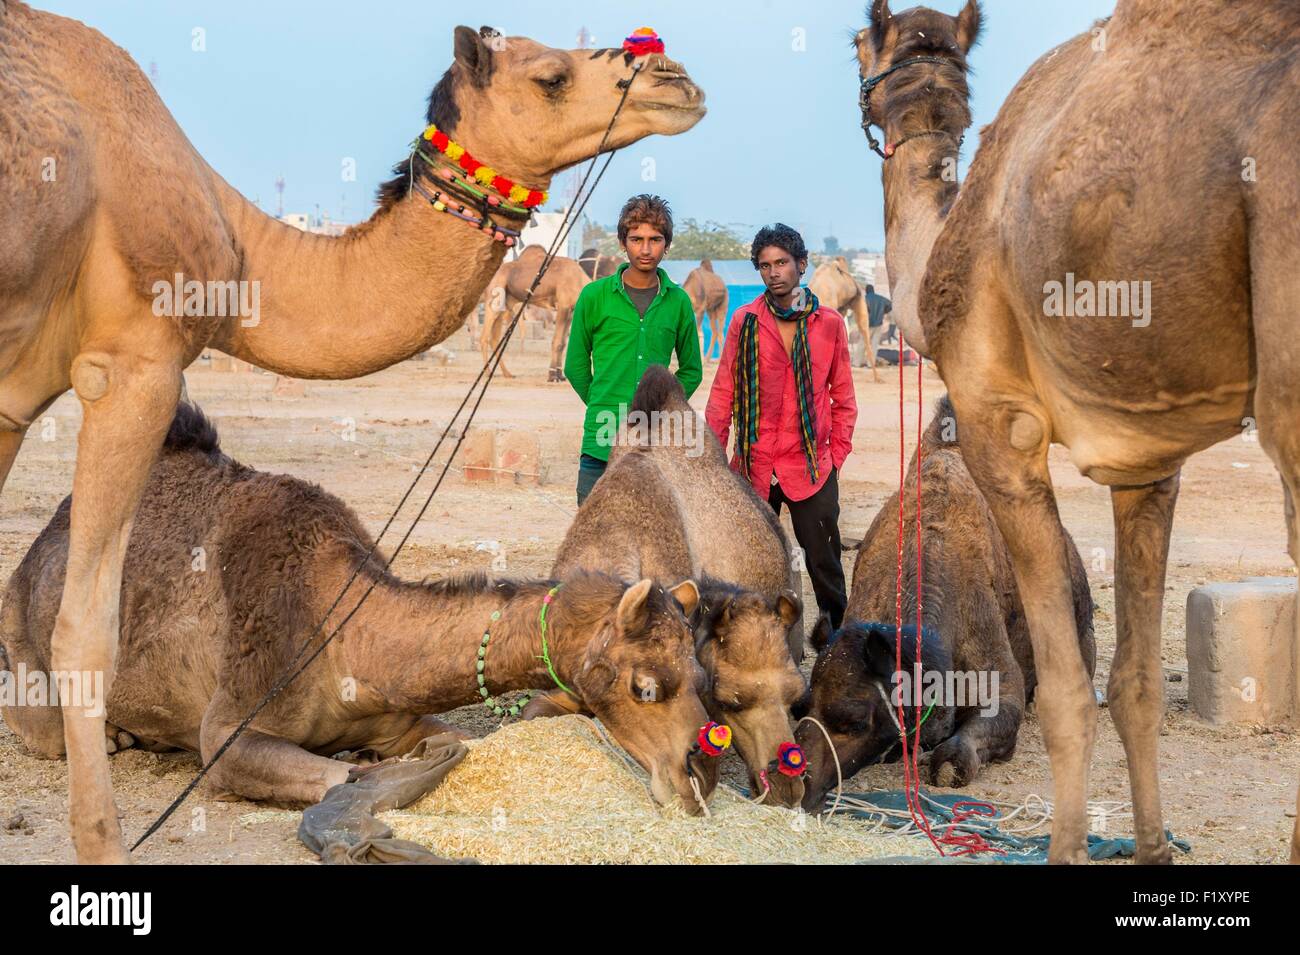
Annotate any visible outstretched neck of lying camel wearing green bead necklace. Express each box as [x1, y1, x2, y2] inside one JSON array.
[[346, 581, 586, 713]]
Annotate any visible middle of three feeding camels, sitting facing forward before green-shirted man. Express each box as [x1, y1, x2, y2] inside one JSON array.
[[525, 365, 805, 807]]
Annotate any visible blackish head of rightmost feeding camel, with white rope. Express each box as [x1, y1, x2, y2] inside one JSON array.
[[796, 616, 952, 812]]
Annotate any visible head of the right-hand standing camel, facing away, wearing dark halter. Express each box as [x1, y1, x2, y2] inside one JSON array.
[[854, 0, 983, 142]]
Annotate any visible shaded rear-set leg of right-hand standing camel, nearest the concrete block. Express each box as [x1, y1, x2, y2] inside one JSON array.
[[1106, 474, 1178, 864]]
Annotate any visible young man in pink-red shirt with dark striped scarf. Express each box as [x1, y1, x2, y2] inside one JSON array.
[[705, 222, 858, 628]]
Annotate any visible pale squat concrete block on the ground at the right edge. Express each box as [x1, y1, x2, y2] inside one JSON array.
[[1187, 577, 1300, 724]]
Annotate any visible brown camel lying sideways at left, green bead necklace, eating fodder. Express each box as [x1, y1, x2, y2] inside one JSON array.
[[0, 404, 718, 812]]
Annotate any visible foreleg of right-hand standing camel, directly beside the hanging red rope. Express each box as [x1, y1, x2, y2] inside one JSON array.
[[945, 392, 1097, 863]]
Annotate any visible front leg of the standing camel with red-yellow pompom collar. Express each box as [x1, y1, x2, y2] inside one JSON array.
[[51, 348, 181, 863]]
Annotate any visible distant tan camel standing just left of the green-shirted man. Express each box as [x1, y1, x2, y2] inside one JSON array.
[[478, 246, 590, 382]]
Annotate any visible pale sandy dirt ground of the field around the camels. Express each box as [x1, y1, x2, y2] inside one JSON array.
[[0, 333, 1300, 864]]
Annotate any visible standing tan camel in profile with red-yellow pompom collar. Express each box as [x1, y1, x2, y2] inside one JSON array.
[[0, 0, 705, 863]]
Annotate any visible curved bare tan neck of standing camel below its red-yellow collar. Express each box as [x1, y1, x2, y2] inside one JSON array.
[[212, 167, 546, 379]]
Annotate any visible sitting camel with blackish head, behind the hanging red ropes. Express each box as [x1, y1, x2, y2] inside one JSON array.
[[797, 396, 1096, 812]]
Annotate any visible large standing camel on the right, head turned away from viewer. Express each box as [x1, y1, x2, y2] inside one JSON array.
[[857, 0, 1300, 863]]
